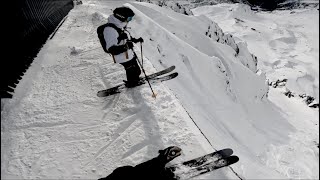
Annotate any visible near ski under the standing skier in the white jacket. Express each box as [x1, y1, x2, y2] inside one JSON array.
[[97, 72, 178, 97]]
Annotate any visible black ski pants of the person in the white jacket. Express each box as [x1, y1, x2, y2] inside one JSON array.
[[120, 57, 141, 83]]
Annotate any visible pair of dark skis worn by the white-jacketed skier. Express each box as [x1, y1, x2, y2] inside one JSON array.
[[97, 66, 178, 97]]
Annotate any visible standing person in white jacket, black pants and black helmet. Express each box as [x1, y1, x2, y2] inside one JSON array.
[[103, 6, 143, 87]]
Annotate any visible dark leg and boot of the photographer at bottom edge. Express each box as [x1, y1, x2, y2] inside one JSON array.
[[99, 146, 181, 180]]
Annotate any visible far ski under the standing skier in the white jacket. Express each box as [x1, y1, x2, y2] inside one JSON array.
[[97, 66, 176, 97]]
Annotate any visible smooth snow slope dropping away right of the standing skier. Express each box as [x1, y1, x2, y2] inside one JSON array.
[[130, 3, 293, 178]]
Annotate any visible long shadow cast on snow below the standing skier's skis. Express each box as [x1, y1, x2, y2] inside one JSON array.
[[122, 89, 164, 159]]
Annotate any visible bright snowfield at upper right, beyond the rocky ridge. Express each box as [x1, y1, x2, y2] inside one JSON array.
[[193, 4, 319, 103]]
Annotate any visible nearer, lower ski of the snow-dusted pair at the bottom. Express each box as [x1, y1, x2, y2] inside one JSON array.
[[173, 156, 239, 179]]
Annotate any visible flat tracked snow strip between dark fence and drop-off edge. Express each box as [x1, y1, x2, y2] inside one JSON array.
[[1, 2, 209, 179]]
